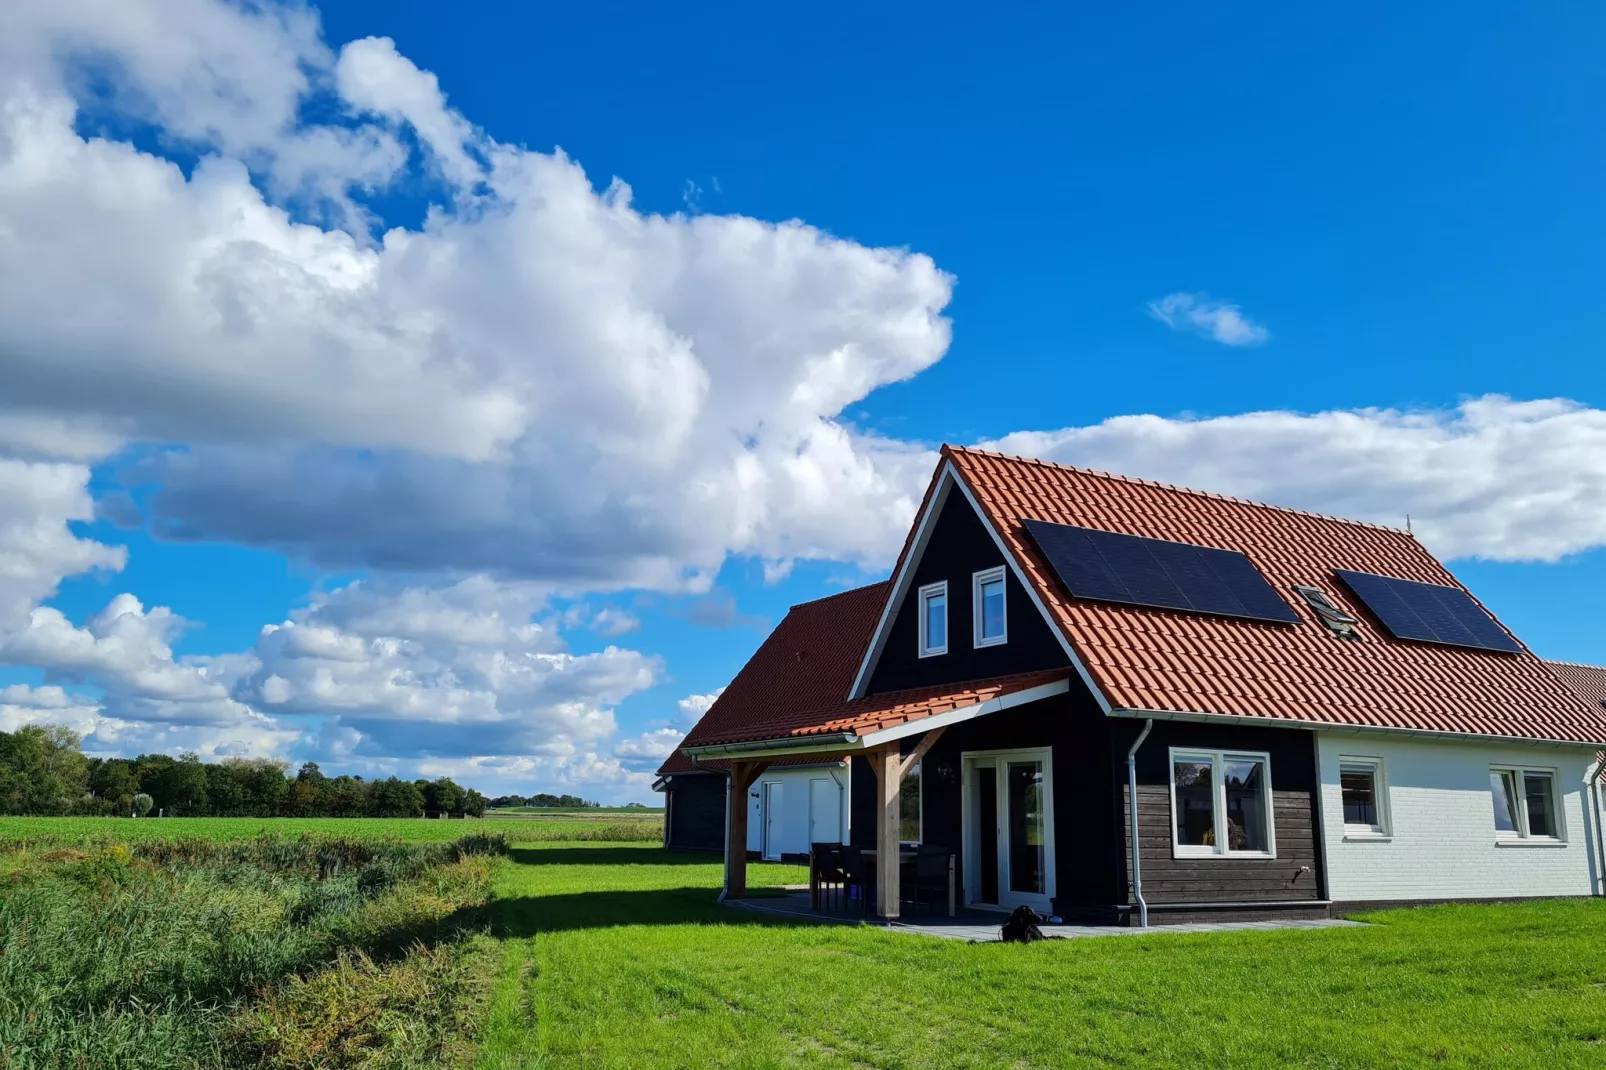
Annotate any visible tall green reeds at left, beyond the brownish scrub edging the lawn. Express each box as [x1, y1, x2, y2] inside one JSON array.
[[0, 834, 507, 1070]]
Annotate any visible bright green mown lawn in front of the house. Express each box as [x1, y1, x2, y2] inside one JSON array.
[[480, 843, 1606, 1070]]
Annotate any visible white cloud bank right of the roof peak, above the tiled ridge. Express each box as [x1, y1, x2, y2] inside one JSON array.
[[984, 395, 1606, 561]]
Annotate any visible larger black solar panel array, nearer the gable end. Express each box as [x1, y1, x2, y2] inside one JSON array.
[[1021, 521, 1299, 623]]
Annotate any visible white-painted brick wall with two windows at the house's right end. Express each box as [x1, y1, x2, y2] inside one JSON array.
[[1317, 733, 1598, 901]]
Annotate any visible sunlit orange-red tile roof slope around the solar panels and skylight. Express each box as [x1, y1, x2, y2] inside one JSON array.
[[937, 447, 1606, 742]]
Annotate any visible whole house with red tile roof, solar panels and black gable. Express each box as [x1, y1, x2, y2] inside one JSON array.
[[665, 447, 1606, 924]]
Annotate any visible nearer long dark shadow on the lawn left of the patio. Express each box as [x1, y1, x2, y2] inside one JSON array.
[[491, 888, 819, 937]]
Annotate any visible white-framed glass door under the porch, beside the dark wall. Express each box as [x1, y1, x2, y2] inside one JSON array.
[[960, 749, 1055, 913]]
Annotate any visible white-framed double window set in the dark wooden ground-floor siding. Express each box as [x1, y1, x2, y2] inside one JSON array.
[[1171, 747, 1277, 858]]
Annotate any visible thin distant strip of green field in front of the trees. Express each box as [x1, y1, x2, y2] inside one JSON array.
[[0, 811, 663, 845]]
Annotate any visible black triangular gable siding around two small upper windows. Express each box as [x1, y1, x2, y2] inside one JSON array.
[[869, 490, 1070, 694]]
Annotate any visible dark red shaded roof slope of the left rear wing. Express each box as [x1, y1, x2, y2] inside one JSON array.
[[658, 582, 890, 776]]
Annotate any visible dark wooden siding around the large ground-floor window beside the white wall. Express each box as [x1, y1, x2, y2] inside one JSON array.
[[1115, 721, 1322, 908]]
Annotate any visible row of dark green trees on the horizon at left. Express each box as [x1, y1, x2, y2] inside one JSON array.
[[0, 725, 596, 818]]
